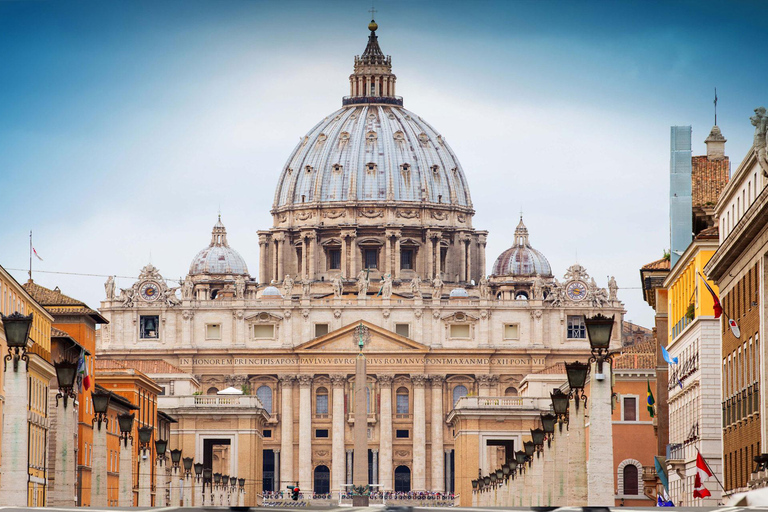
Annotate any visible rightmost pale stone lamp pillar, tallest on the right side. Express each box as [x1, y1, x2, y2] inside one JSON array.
[[587, 362, 615, 507]]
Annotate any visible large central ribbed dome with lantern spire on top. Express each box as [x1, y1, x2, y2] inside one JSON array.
[[274, 22, 472, 211]]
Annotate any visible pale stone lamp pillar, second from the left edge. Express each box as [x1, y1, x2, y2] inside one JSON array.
[[50, 398, 77, 507]]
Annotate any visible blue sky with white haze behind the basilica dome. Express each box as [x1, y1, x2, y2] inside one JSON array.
[[0, 0, 768, 327]]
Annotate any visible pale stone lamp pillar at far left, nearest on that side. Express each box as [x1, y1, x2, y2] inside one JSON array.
[[0, 361, 29, 507]]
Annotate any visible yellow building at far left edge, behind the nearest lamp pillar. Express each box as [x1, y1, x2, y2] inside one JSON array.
[[0, 266, 55, 506]]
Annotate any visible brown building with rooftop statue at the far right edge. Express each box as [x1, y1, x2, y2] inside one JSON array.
[[704, 107, 768, 494]]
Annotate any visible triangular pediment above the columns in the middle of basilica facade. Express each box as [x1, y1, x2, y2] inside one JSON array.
[[294, 321, 429, 354]]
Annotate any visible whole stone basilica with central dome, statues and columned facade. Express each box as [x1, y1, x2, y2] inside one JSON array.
[[98, 22, 624, 500]]
